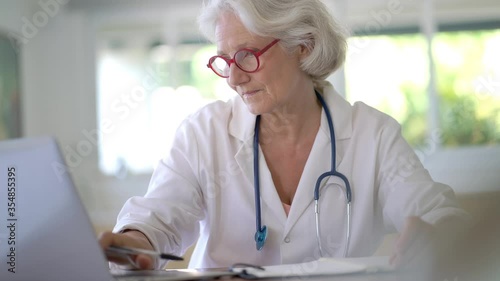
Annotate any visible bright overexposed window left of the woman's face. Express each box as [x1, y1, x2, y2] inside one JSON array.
[[98, 27, 233, 177]]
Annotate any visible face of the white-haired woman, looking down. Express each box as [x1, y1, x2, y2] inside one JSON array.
[[216, 12, 312, 115]]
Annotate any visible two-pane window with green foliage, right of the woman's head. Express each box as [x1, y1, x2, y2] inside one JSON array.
[[345, 30, 500, 147]]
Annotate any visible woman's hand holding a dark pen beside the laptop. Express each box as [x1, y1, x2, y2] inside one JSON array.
[[99, 230, 155, 270]]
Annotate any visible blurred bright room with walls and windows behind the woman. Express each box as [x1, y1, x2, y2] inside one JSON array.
[[0, 0, 500, 262]]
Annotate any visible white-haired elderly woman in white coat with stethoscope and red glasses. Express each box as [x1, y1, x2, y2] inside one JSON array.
[[100, 0, 465, 268]]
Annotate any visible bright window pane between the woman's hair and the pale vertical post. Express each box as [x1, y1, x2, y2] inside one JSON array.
[[345, 35, 429, 146]]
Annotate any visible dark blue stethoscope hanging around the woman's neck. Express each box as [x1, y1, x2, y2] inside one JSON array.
[[253, 91, 352, 257]]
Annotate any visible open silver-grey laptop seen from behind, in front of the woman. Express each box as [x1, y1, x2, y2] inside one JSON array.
[[0, 137, 235, 281]]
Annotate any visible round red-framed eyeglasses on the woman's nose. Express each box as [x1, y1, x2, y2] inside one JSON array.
[[207, 39, 279, 78]]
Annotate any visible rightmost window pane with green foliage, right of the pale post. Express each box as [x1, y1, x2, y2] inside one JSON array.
[[433, 30, 500, 146]]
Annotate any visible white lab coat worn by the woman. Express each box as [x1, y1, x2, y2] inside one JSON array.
[[115, 82, 464, 268]]
